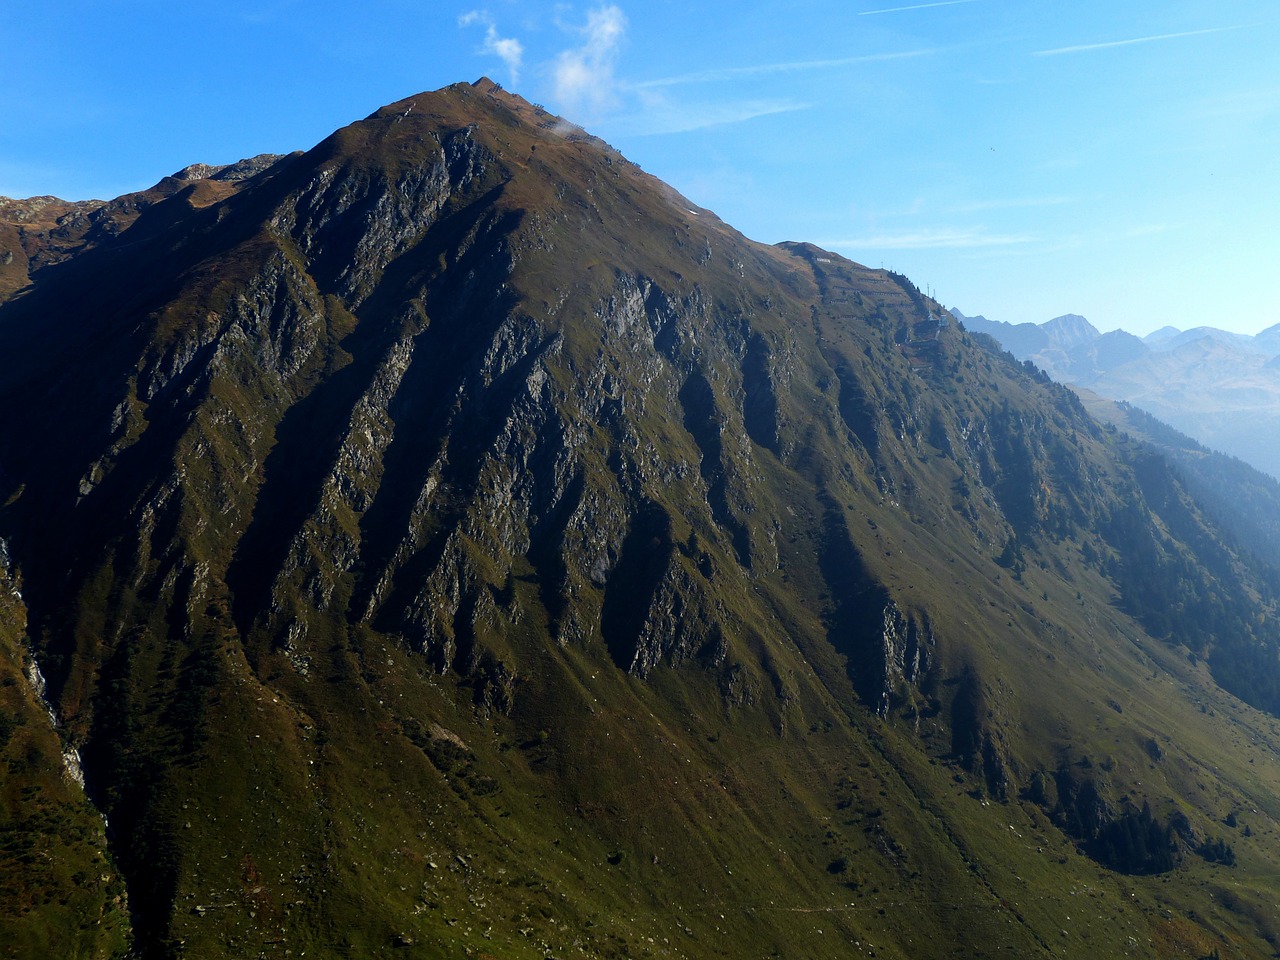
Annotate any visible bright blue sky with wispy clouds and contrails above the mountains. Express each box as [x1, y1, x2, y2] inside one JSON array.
[[0, 0, 1280, 334]]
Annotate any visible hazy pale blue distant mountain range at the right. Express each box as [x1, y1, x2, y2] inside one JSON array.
[[951, 310, 1280, 476]]
